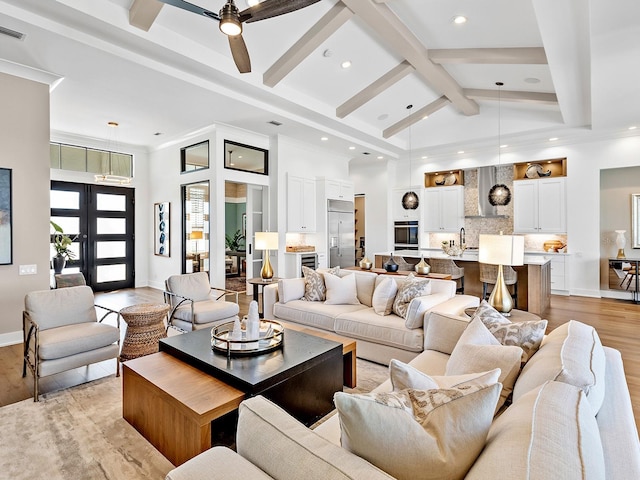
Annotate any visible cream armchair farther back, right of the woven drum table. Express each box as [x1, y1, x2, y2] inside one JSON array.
[[164, 272, 240, 331]]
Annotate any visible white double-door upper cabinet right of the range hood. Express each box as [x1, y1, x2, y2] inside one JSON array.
[[513, 177, 567, 233]]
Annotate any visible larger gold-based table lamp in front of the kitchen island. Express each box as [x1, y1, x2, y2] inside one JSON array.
[[478, 232, 524, 317]]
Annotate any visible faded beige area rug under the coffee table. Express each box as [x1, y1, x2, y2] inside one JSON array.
[[0, 359, 387, 480]]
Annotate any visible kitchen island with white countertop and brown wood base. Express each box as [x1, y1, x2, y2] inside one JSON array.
[[375, 248, 551, 315]]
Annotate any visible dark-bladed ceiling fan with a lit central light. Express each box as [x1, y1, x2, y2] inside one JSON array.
[[160, 0, 320, 73]]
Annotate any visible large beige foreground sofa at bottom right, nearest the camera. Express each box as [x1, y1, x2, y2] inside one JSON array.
[[167, 320, 640, 480]]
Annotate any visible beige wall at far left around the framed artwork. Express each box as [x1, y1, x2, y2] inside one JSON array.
[[0, 73, 49, 344]]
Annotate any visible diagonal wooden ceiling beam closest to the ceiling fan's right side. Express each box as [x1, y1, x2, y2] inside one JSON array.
[[262, 2, 353, 87]]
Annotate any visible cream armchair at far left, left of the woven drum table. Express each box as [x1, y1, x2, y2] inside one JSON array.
[[22, 286, 120, 402]]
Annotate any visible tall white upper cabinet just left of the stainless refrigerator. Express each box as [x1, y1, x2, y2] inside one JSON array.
[[287, 175, 316, 233]]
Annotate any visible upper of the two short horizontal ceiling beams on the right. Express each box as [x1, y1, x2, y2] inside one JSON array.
[[429, 47, 547, 65]]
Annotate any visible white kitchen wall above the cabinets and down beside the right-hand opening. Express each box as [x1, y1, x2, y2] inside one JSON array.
[[382, 129, 640, 297]]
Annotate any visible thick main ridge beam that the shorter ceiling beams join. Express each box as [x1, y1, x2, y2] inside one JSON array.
[[342, 0, 480, 115]]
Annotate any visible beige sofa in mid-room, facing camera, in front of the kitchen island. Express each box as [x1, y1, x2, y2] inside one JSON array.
[[263, 270, 479, 365]]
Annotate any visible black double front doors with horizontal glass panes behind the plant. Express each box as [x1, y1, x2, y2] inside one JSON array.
[[50, 181, 135, 291]]
